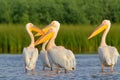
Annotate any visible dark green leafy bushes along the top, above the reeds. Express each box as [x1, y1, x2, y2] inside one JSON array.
[[0, 0, 120, 24]]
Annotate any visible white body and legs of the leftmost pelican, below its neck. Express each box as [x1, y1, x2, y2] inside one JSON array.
[[23, 47, 38, 73]]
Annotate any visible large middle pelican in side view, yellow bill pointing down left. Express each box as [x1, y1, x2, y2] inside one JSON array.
[[35, 21, 76, 73]]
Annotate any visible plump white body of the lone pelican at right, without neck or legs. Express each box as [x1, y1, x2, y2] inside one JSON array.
[[98, 46, 119, 66]]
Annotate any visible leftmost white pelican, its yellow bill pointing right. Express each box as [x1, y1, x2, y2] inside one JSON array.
[[23, 23, 42, 73]]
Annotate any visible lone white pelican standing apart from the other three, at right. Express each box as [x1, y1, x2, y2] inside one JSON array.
[[88, 20, 119, 72]]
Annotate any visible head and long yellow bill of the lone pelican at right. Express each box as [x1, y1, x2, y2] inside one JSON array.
[[88, 20, 111, 39]]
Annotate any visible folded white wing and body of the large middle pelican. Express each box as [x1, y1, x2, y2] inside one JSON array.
[[48, 47, 76, 70]]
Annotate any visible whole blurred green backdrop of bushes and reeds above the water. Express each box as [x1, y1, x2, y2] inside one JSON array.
[[0, 0, 120, 54]]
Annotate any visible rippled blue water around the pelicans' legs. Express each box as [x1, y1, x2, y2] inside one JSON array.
[[0, 55, 120, 80]]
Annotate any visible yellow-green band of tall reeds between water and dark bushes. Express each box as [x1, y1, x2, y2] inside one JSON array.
[[0, 24, 120, 53]]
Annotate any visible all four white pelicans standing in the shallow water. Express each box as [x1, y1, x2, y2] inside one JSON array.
[[23, 20, 119, 73]]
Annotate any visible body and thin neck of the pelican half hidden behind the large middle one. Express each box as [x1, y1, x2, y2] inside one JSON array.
[[40, 41, 52, 71]]
